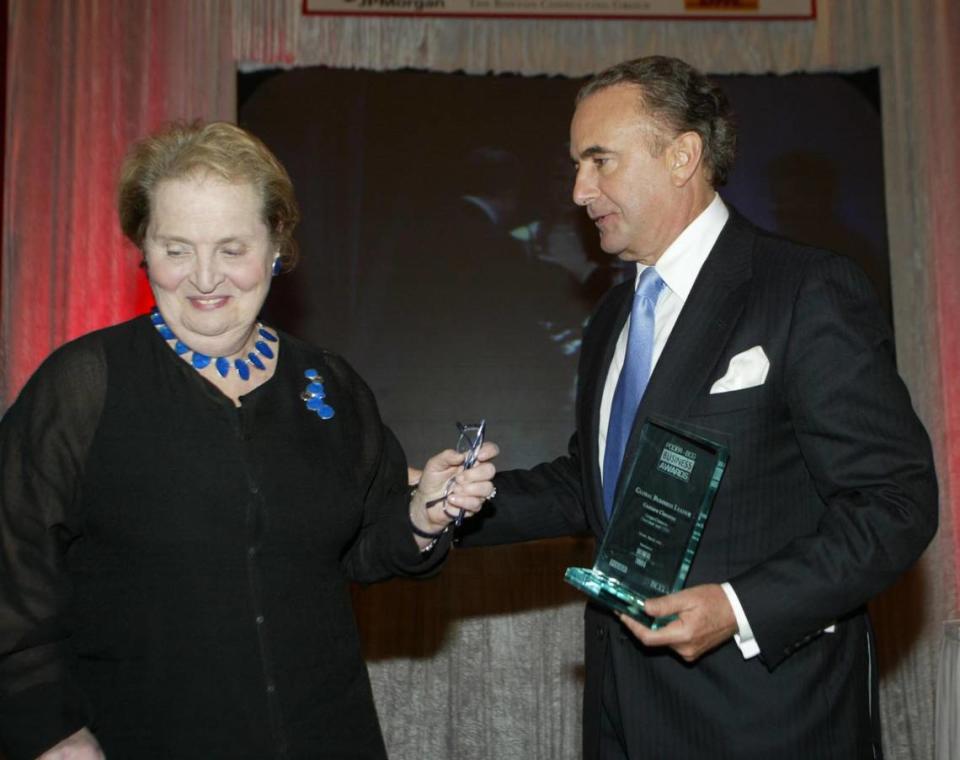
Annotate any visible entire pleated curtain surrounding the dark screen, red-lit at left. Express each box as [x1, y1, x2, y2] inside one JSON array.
[[0, 0, 960, 760]]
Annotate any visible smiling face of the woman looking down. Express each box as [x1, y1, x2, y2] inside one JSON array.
[[143, 174, 277, 356]]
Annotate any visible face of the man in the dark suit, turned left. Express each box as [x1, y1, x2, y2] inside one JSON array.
[[570, 84, 686, 265]]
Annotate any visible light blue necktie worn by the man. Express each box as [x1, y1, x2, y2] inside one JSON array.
[[603, 267, 664, 517]]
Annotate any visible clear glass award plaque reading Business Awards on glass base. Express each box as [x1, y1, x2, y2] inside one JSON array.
[[564, 419, 727, 628]]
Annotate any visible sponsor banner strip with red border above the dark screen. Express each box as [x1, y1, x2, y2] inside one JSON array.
[[303, 0, 816, 21]]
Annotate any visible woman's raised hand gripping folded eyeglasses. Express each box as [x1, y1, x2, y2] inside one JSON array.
[[410, 441, 500, 549]]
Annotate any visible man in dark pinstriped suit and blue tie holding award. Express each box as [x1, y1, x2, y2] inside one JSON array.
[[464, 57, 937, 760]]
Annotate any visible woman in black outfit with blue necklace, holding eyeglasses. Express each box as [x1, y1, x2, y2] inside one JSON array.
[[0, 123, 496, 760]]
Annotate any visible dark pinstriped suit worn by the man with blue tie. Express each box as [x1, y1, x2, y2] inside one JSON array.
[[465, 213, 937, 760]]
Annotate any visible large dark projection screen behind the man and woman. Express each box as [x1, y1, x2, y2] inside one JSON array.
[[239, 68, 889, 478]]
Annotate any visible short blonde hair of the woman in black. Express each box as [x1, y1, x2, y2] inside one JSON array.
[[117, 121, 300, 270]]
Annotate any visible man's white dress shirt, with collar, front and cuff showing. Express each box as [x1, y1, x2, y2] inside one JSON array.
[[598, 194, 760, 658]]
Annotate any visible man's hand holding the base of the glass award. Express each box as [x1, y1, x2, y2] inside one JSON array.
[[619, 583, 737, 662]]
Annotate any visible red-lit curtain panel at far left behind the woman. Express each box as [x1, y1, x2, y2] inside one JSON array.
[[0, 0, 236, 408]]
